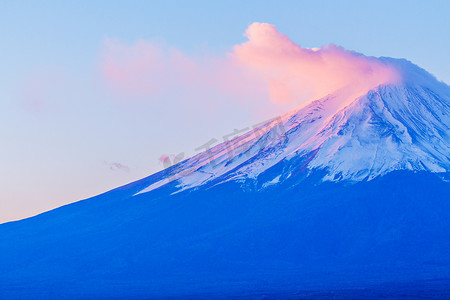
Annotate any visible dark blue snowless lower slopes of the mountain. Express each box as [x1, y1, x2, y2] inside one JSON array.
[[0, 170, 450, 299]]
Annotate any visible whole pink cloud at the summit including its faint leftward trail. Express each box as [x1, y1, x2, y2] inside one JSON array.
[[100, 23, 398, 107]]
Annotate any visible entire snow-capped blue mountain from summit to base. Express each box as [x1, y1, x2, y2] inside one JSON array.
[[0, 58, 450, 298]]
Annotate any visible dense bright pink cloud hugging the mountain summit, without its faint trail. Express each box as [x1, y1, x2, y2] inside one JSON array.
[[230, 23, 398, 103]]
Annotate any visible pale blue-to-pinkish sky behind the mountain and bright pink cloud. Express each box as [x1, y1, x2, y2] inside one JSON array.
[[0, 1, 450, 223]]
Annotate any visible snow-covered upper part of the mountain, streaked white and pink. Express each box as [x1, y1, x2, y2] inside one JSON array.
[[140, 59, 450, 193]]
